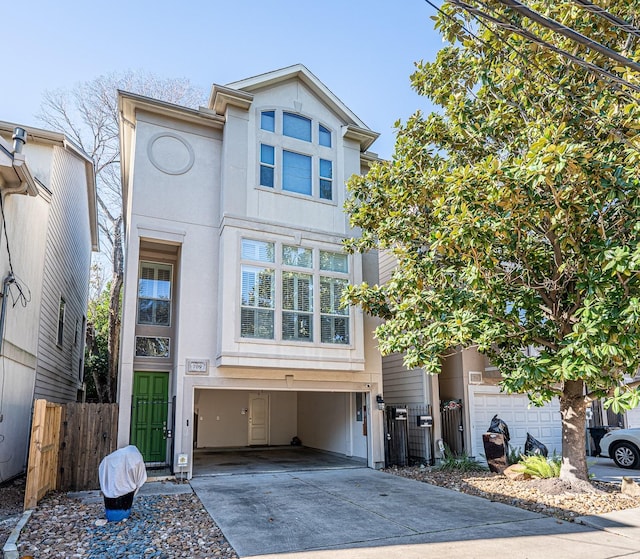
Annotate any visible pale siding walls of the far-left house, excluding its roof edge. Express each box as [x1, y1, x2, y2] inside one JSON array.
[[0, 135, 91, 482]]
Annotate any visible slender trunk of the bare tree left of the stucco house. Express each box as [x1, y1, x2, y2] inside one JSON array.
[[107, 215, 124, 403]]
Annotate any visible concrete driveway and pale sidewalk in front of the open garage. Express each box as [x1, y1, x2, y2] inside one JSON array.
[[191, 468, 640, 559]]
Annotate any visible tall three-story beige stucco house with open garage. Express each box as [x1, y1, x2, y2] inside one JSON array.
[[118, 65, 384, 476]]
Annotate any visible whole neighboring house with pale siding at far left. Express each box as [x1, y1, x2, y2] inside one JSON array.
[[0, 122, 98, 482]]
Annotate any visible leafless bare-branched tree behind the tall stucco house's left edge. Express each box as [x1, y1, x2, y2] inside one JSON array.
[[38, 71, 205, 402]]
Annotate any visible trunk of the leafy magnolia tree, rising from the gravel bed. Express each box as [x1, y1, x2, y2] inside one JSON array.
[[560, 380, 594, 491]]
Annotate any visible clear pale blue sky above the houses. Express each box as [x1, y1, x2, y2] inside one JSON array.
[[0, 0, 442, 157]]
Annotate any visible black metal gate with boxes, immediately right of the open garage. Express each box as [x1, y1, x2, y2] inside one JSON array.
[[384, 405, 434, 467]]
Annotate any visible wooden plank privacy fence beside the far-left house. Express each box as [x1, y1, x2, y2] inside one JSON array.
[[24, 400, 118, 509]]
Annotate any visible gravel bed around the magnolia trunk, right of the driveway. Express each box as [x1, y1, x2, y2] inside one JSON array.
[[385, 466, 640, 521]]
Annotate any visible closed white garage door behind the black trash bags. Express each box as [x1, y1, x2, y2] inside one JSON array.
[[469, 385, 562, 458]]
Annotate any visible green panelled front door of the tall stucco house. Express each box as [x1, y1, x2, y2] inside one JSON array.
[[131, 372, 170, 464]]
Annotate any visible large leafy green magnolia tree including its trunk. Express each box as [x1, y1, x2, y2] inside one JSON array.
[[346, 0, 640, 488]]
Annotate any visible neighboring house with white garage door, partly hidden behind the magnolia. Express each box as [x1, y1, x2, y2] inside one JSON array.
[[380, 252, 562, 464]]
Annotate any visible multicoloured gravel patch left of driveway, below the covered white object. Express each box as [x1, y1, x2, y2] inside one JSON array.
[[0, 484, 238, 559]]
